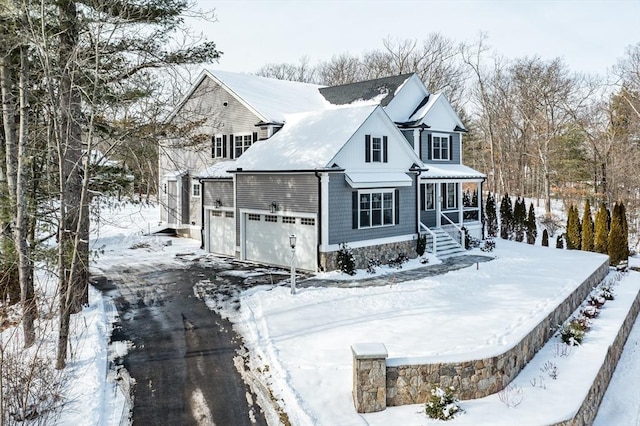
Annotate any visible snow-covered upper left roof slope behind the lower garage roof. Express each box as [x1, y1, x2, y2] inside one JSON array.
[[209, 71, 329, 123]]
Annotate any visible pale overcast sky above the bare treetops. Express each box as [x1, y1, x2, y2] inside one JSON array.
[[192, 0, 640, 76]]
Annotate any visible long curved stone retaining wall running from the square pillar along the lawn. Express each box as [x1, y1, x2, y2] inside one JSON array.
[[354, 260, 609, 413]]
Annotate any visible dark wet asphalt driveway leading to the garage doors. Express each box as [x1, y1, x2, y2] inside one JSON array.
[[93, 261, 288, 426]]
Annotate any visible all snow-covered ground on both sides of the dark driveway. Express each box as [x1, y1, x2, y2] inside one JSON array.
[[3, 201, 640, 426]]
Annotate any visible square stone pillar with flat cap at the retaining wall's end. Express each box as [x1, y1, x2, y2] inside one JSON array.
[[351, 343, 388, 413]]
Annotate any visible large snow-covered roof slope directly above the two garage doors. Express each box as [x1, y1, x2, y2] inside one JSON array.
[[236, 105, 379, 170]]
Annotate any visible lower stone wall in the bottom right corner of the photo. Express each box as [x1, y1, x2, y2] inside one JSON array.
[[556, 274, 640, 426]]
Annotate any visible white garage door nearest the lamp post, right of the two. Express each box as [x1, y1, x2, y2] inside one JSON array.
[[244, 213, 317, 271]]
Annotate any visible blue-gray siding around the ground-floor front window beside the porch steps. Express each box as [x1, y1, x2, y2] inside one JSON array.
[[329, 173, 416, 244]]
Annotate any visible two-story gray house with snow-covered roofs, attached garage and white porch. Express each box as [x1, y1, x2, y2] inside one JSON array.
[[160, 71, 484, 271]]
